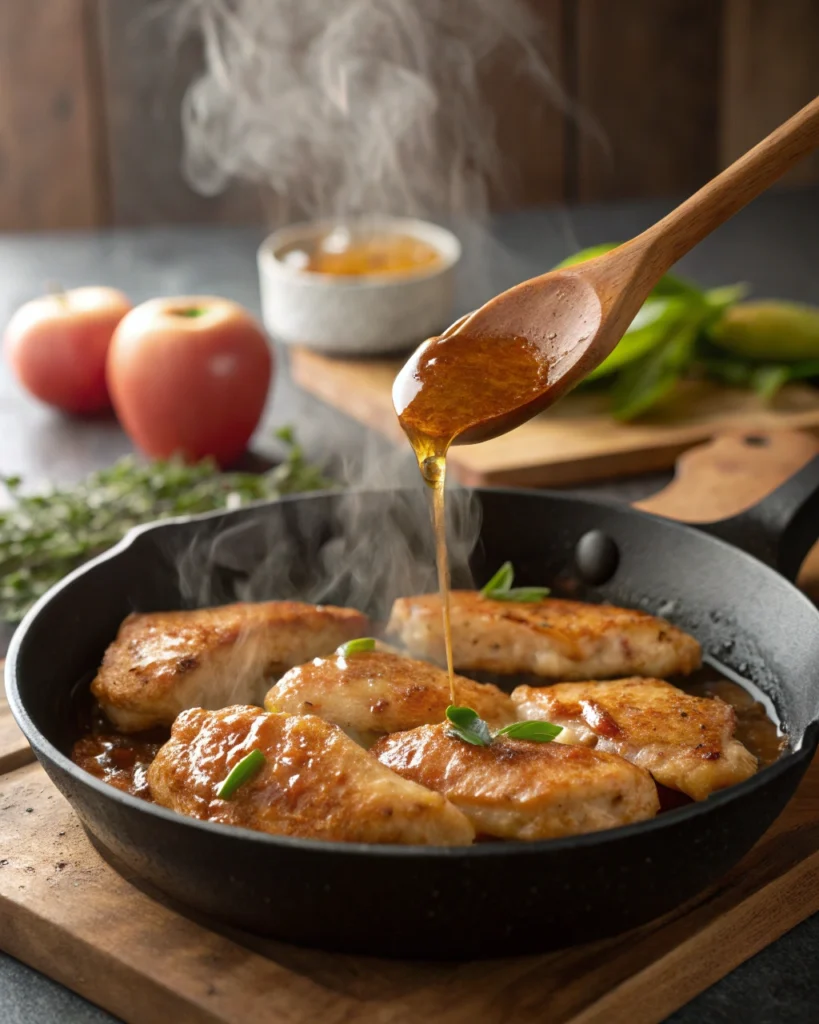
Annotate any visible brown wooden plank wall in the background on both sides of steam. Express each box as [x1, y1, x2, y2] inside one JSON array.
[[0, 0, 819, 230]]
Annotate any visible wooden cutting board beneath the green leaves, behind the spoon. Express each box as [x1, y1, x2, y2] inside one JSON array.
[[290, 348, 819, 486]]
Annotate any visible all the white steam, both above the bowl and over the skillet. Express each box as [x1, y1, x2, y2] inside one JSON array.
[[157, 0, 567, 630]]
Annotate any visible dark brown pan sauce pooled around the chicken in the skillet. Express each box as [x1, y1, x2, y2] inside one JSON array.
[[72, 666, 787, 811]]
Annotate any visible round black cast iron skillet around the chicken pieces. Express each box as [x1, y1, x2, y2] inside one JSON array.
[[6, 459, 819, 958]]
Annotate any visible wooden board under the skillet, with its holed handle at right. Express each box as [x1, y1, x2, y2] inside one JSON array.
[[0, 434, 819, 1024]]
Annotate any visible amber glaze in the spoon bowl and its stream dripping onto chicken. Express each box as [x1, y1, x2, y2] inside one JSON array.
[[392, 332, 549, 705]]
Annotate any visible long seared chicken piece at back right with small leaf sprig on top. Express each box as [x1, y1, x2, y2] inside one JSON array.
[[387, 590, 700, 679]]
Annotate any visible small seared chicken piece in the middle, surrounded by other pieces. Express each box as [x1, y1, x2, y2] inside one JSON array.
[[264, 650, 515, 746]]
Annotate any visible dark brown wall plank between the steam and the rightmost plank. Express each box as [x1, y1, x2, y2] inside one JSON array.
[[574, 0, 720, 200]]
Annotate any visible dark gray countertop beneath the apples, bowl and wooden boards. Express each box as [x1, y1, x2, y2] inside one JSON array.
[[0, 188, 819, 1024]]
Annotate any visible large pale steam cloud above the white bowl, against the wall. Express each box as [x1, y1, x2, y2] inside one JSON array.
[[173, 0, 565, 217]]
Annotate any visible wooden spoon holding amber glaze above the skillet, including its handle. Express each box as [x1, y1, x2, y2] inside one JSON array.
[[392, 97, 819, 463]]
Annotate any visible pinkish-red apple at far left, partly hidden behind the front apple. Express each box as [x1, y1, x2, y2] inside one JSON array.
[[4, 288, 131, 414]]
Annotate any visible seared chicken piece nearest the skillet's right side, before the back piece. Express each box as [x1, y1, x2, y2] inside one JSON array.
[[512, 679, 757, 800]]
